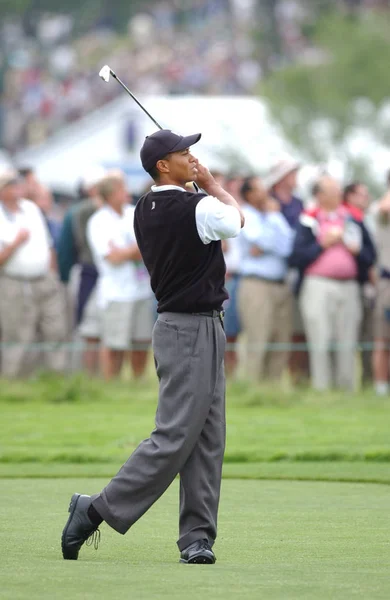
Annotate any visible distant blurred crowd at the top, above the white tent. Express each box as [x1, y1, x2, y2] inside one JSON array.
[[0, 0, 386, 152]]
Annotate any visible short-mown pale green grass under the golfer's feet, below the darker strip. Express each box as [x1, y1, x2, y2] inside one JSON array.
[[0, 479, 390, 600]]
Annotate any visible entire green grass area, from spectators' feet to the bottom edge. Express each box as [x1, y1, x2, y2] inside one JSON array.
[[0, 376, 390, 600]]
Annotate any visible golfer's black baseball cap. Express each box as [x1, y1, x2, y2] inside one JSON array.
[[140, 129, 202, 172]]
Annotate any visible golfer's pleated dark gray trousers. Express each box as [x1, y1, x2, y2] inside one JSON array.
[[93, 312, 226, 550]]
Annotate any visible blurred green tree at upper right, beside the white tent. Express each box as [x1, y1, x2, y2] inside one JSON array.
[[260, 11, 390, 189]]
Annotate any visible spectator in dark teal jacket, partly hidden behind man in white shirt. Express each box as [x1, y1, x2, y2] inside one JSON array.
[[58, 166, 106, 375]]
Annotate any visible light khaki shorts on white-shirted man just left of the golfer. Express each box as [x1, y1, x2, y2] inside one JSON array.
[[102, 298, 155, 350]]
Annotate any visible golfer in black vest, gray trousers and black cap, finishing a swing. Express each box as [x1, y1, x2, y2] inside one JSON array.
[[62, 130, 244, 564]]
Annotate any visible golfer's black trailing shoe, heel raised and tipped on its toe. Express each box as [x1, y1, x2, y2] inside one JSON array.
[[61, 494, 100, 560]]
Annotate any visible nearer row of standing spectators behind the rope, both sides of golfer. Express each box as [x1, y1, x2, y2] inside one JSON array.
[[0, 157, 390, 394]]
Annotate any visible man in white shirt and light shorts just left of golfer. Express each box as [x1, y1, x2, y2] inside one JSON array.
[[87, 172, 154, 379]]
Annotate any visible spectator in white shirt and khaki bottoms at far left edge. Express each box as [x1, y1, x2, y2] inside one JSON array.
[[0, 169, 66, 377]]
